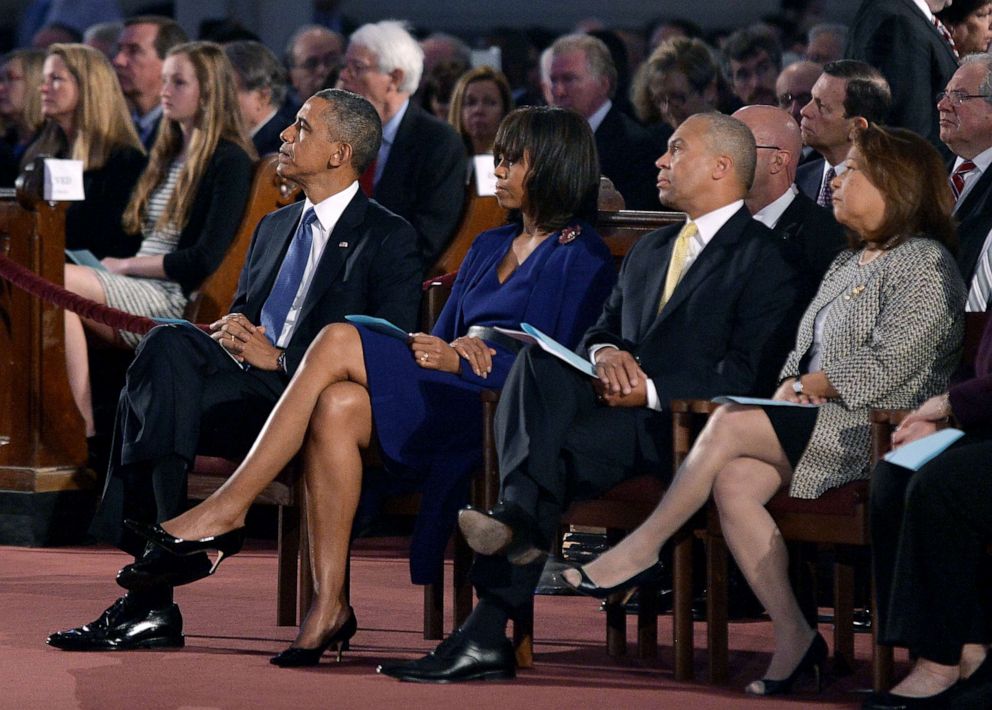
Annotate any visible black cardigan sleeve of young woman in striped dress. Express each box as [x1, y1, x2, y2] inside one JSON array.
[[163, 144, 252, 291]]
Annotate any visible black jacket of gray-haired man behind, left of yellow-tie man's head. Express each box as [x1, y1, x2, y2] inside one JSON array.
[[595, 106, 665, 210]]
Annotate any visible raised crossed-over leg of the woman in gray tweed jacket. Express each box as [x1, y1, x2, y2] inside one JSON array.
[[564, 405, 788, 587]]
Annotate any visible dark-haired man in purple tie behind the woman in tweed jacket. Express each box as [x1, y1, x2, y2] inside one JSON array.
[[796, 59, 891, 207]]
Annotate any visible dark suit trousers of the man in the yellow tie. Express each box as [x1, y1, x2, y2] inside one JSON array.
[[472, 348, 671, 616]]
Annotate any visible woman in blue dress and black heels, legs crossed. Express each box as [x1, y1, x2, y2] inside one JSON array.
[[129, 107, 616, 666]]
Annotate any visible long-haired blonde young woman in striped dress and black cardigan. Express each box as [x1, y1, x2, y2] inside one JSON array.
[[65, 42, 256, 437]]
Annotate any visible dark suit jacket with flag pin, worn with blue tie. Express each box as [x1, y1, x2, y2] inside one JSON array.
[[231, 190, 424, 375]]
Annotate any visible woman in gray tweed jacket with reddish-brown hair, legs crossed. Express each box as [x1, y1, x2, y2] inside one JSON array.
[[563, 126, 965, 695]]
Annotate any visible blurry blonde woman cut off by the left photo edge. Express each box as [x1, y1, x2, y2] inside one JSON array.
[[0, 49, 45, 187]]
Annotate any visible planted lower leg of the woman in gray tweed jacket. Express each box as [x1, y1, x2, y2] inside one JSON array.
[[713, 459, 815, 692]]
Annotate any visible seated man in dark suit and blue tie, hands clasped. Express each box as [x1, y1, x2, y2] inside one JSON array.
[[48, 89, 423, 651]]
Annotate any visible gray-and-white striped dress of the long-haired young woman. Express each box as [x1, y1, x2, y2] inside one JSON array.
[[96, 160, 188, 347]]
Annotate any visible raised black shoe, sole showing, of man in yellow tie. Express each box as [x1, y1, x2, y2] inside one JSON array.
[[458, 502, 548, 565]]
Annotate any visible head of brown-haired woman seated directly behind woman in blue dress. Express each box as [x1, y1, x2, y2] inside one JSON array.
[[448, 67, 513, 155]]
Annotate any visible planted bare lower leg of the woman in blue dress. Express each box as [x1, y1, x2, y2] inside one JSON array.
[[293, 382, 372, 648]]
